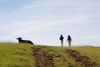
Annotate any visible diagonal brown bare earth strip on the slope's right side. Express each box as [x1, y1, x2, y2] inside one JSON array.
[[66, 49, 97, 67]]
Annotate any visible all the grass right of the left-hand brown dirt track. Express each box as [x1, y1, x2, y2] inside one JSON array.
[[37, 46, 100, 67]]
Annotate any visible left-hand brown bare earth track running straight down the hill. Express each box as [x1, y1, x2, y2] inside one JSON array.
[[33, 47, 56, 67]]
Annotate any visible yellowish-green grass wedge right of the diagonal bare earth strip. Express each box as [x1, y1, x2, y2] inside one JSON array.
[[70, 46, 100, 66]]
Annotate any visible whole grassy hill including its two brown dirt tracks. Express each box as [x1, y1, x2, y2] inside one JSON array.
[[0, 43, 100, 67]]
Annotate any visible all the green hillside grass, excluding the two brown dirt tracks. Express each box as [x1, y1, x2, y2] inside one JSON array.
[[0, 43, 100, 67]]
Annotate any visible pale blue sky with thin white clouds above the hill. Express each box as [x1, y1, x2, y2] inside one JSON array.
[[0, 0, 100, 46]]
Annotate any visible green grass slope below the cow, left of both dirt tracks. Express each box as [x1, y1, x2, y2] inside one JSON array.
[[0, 43, 35, 67]]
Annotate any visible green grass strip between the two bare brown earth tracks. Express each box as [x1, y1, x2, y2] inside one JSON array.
[[43, 46, 81, 67]]
